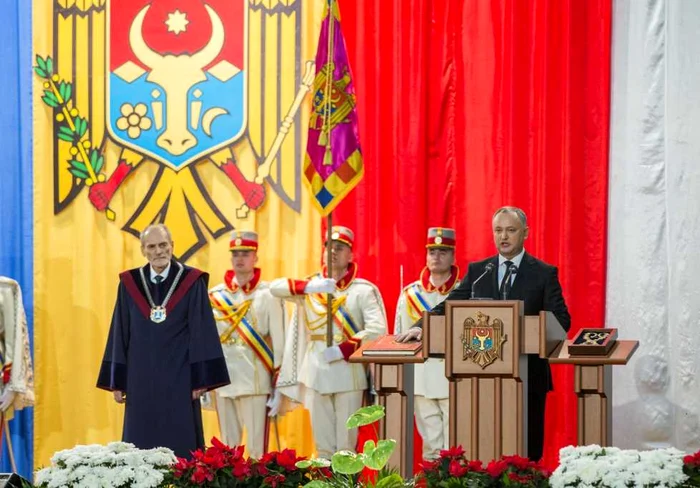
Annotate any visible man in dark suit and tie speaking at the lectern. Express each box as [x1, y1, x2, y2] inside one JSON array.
[[398, 207, 571, 460]]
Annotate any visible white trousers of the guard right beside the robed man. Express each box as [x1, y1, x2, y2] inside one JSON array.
[[216, 395, 267, 459]]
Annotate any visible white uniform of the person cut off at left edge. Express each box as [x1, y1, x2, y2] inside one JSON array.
[[0, 276, 34, 420]]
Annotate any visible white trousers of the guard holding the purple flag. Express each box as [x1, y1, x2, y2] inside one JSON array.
[[304, 388, 364, 459]]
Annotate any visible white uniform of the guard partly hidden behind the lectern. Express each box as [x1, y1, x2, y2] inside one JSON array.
[[394, 266, 459, 459]]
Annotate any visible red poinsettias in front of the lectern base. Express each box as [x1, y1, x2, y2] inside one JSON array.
[[419, 446, 549, 488]]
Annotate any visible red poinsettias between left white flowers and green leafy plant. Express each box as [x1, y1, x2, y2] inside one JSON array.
[[166, 438, 330, 488]]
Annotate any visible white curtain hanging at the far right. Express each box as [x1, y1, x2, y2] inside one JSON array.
[[606, 0, 700, 452]]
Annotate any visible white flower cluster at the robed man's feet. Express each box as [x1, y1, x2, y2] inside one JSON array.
[[35, 442, 176, 488]]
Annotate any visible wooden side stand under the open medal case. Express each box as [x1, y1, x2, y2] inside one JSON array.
[[549, 341, 639, 446]]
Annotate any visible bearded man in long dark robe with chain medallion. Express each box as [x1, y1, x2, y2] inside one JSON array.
[[97, 224, 230, 457]]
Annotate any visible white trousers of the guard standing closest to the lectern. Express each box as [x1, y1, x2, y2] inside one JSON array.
[[413, 396, 450, 460]]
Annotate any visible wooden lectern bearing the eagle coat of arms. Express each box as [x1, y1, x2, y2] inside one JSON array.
[[423, 300, 566, 462]]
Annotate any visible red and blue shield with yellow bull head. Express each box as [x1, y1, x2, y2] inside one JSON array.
[[106, 0, 247, 171]]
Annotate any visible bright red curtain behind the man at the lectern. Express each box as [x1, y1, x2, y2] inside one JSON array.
[[333, 0, 612, 466]]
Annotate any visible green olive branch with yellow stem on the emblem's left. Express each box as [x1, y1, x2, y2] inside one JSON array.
[[34, 55, 106, 186]]
